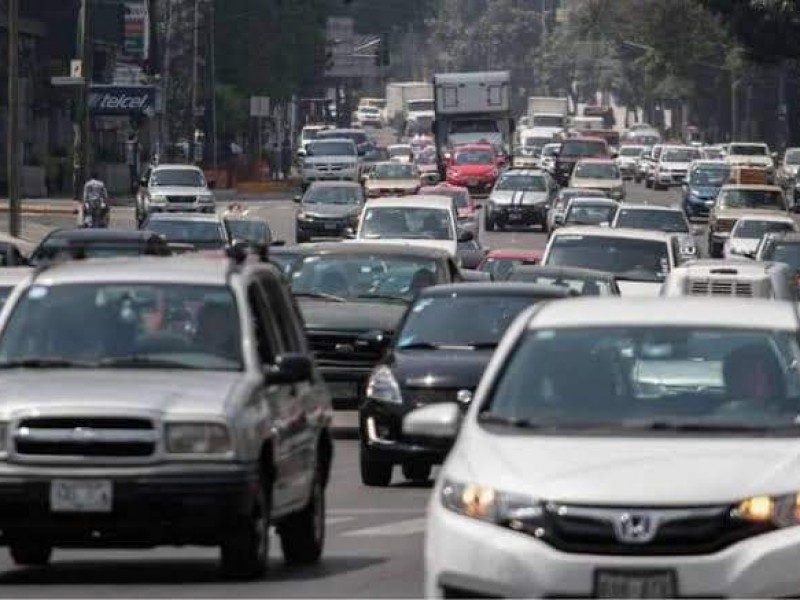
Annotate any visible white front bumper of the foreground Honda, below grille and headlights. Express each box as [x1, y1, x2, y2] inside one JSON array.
[[425, 502, 800, 598]]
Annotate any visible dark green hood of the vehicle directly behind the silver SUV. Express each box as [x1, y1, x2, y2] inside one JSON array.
[[297, 298, 406, 332]]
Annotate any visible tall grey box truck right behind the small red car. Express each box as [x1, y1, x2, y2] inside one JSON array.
[[433, 71, 514, 170]]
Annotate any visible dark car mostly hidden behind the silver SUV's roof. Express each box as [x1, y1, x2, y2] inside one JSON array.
[[29, 229, 172, 266]]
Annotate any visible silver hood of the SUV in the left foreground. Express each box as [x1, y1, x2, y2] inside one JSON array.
[[0, 369, 244, 420]]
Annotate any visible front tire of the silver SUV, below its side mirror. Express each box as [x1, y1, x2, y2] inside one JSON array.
[[220, 468, 272, 580]]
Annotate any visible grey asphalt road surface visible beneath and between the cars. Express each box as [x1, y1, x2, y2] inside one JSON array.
[[0, 178, 679, 598]]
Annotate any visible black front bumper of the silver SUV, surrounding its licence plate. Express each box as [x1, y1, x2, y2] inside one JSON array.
[[0, 464, 258, 547]]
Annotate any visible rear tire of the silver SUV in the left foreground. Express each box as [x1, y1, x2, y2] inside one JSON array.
[[278, 472, 325, 565]]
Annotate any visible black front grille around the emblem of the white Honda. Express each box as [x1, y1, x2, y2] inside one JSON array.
[[536, 505, 773, 556]]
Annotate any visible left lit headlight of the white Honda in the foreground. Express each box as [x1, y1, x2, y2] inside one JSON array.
[[440, 479, 544, 534]]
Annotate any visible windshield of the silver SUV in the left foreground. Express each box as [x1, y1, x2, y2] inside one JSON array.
[[0, 283, 243, 370]]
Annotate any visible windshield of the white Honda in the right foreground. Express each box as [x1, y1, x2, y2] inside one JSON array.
[[481, 326, 800, 435]]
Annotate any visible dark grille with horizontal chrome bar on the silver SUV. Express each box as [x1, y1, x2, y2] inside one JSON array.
[[13, 417, 158, 458]]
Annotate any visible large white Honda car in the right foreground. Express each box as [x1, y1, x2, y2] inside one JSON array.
[[412, 298, 800, 598]]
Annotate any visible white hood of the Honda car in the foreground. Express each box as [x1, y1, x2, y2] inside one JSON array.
[[453, 427, 800, 507]]
